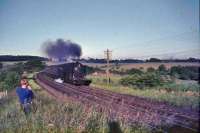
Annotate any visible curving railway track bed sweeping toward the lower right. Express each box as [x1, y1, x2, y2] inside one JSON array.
[[36, 72, 199, 132]]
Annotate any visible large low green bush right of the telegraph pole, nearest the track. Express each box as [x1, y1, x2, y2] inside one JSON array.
[[120, 73, 164, 88]]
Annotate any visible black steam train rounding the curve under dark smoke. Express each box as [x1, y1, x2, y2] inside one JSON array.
[[44, 62, 91, 85]]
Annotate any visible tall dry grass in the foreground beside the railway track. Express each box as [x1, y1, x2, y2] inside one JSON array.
[[0, 80, 150, 133]]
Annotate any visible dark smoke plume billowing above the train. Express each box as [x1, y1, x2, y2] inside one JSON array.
[[42, 39, 82, 60]]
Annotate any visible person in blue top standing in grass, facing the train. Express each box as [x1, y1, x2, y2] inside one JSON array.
[[16, 79, 34, 114]]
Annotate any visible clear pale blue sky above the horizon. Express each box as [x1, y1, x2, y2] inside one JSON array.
[[0, 0, 200, 59]]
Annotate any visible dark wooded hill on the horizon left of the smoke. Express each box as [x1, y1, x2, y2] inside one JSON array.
[[0, 55, 47, 61]]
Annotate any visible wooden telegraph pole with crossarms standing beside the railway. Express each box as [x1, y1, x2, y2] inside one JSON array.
[[104, 49, 112, 84]]
